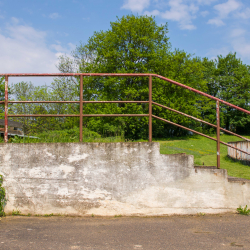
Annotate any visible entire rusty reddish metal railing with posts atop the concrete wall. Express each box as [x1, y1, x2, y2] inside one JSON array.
[[0, 73, 250, 168]]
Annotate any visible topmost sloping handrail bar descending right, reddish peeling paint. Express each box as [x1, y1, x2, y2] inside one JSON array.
[[154, 75, 250, 115]]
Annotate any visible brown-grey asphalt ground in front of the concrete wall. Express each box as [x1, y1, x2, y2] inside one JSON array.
[[0, 214, 250, 250]]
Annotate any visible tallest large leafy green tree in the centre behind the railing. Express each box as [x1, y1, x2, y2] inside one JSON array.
[[58, 15, 206, 139]]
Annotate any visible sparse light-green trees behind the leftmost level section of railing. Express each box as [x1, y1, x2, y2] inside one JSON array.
[[9, 79, 79, 134]]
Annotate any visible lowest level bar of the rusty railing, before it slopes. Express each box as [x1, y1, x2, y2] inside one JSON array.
[[8, 114, 148, 117]]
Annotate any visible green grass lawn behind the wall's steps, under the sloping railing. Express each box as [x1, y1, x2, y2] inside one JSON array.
[[158, 135, 250, 179]]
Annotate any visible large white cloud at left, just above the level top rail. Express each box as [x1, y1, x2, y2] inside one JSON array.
[[0, 18, 73, 85]]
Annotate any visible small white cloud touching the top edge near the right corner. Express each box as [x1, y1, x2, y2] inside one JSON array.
[[207, 0, 242, 26]]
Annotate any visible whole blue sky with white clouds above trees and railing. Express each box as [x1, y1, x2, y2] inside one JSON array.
[[0, 0, 250, 84]]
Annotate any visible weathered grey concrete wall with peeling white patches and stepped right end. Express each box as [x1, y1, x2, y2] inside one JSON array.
[[0, 143, 250, 215]]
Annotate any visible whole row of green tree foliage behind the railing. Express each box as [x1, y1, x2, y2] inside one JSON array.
[[7, 15, 250, 139]]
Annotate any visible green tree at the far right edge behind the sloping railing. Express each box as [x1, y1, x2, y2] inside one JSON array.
[[216, 53, 250, 133]]
